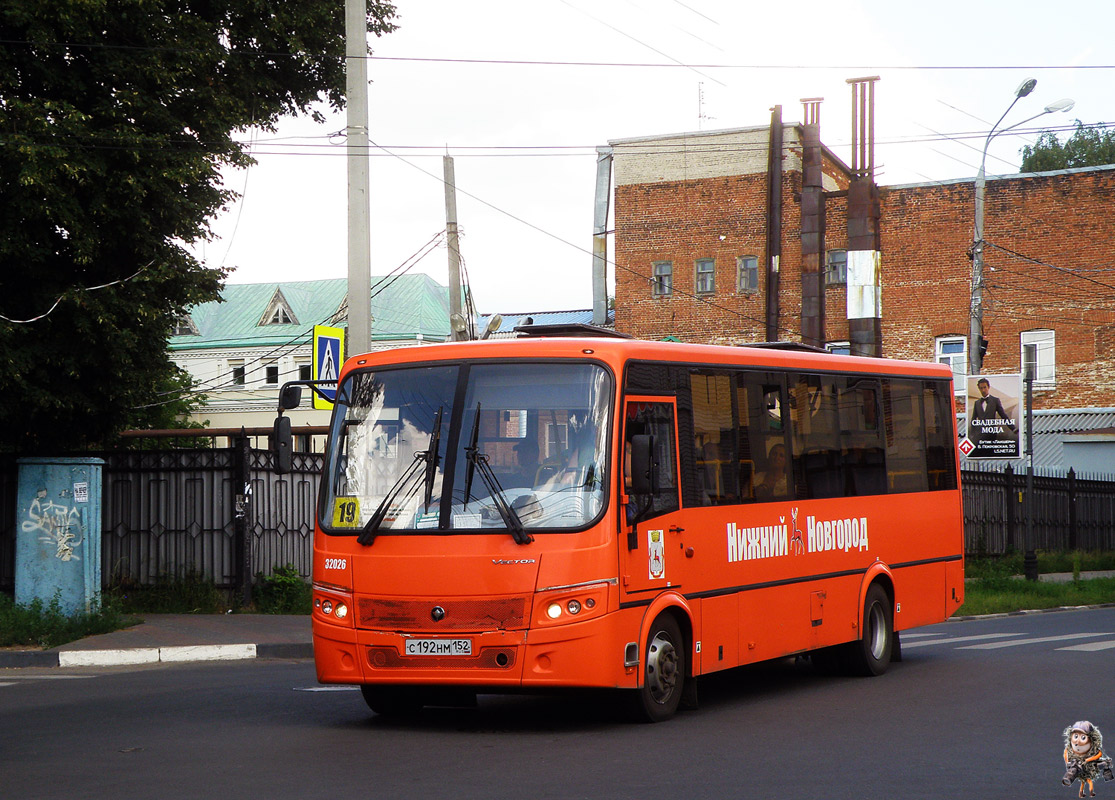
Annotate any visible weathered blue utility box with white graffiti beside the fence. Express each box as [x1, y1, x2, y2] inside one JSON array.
[[16, 459, 105, 614]]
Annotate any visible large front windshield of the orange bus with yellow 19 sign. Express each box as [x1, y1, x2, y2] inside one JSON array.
[[321, 362, 614, 541]]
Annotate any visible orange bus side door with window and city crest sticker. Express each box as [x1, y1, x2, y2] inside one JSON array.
[[620, 396, 685, 599]]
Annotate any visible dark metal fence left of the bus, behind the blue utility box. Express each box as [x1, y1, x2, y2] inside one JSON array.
[[0, 440, 322, 594]]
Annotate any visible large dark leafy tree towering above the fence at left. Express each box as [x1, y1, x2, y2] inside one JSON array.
[[0, 0, 395, 453]]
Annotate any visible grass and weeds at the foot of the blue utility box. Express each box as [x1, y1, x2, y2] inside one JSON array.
[[0, 594, 133, 647]]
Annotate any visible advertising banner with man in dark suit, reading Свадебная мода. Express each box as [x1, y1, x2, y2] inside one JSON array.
[[960, 374, 1022, 459]]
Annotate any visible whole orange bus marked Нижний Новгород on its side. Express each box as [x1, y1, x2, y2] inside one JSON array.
[[277, 321, 963, 721]]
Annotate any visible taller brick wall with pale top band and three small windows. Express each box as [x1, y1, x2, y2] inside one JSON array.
[[611, 126, 849, 344]]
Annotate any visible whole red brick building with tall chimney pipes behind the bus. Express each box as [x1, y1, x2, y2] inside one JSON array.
[[610, 122, 1115, 408]]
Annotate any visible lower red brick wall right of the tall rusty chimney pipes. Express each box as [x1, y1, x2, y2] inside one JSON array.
[[881, 167, 1115, 408]]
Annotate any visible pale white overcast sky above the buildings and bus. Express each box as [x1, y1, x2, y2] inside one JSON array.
[[187, 0, 1115, 314]]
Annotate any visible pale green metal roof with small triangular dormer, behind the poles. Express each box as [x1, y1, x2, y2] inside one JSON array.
[[169, 273, 449, 350]]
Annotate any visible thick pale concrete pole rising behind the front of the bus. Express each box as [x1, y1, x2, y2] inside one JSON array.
[[345, 0, 371, 355]]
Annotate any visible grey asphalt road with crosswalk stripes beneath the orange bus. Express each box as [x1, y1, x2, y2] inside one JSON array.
[[0, 608, 1115, 800]]
